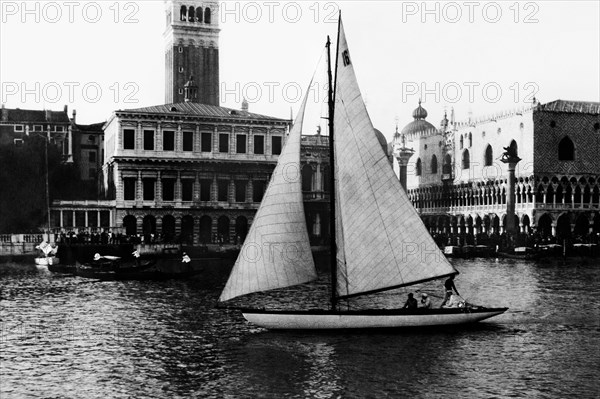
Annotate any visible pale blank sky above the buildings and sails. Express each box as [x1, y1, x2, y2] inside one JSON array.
[[0, 0, 600, 140]]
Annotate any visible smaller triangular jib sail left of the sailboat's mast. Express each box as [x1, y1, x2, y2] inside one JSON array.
[[219, 86, 317, 301]]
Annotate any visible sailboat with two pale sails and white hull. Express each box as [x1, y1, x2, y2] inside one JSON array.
[[219, 17, 508, 330]]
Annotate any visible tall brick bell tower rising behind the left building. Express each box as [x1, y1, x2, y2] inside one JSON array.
[[164, 0, 220, 105]]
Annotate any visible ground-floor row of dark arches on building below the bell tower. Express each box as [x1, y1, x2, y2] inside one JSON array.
[[123, 215, 248, 244]]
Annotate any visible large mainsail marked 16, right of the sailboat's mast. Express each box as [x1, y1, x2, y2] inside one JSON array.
[[334, 21, 456, 297]]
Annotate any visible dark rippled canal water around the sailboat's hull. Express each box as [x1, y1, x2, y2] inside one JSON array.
[[0, 259, 600, 399]]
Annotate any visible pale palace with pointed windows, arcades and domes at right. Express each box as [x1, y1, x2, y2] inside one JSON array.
[[394, 100, 600, 242]]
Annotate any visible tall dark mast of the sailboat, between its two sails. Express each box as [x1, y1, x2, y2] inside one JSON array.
[[326, 16, 341, 310]]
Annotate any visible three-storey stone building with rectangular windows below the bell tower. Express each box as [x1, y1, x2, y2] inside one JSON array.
[[95, 102, 289, 243]]
